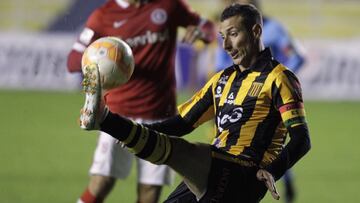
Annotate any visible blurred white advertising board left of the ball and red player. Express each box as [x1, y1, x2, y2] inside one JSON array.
[[0, 33, 81, 91]]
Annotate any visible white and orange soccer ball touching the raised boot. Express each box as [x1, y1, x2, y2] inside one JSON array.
[[81, 37, 134, 90]]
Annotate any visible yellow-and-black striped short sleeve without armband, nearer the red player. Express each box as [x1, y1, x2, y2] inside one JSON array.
[[178, 74, 220, 128]]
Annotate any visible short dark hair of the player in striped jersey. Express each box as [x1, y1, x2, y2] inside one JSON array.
[[220, 3, 262, 29]]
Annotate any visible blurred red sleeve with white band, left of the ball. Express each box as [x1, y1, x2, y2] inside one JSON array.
[[67, 10, 101, 72]]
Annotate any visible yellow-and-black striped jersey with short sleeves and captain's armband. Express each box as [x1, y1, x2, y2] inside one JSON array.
[[178, 49, 305, 165]]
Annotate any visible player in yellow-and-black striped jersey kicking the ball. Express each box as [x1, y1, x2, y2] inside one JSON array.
[[81, 4, 310, 203]]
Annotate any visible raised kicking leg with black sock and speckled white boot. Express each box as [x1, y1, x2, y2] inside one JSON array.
[[80, 65, 211, 198]]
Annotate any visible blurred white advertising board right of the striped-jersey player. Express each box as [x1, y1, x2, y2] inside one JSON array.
[[299, 38, 360, 100]]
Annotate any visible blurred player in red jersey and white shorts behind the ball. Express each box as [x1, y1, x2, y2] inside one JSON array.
[[68, 0, 215, 203]]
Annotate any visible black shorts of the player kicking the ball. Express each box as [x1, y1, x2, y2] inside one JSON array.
[[165, 149, 267, 203]]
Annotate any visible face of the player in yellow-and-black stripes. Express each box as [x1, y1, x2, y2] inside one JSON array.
[[220, 16, 258, 68]]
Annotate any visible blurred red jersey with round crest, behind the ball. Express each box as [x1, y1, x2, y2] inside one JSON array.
[[68, 0, 200, 119]]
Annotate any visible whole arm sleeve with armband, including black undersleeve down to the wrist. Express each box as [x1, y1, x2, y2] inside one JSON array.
[[265, 69, 311, 180]]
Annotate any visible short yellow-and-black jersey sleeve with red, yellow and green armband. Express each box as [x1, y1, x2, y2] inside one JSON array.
[[272, 70, 306, 128]]
